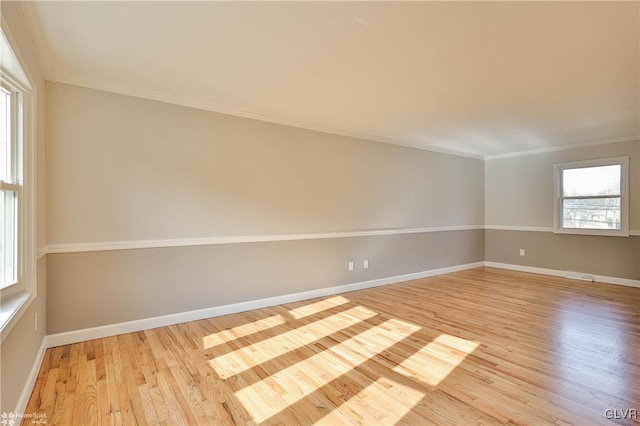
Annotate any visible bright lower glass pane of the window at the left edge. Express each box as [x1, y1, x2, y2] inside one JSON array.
[[0, 191, 17, 288]]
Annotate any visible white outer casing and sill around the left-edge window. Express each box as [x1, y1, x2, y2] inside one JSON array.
[[0, 17, 38, 343]]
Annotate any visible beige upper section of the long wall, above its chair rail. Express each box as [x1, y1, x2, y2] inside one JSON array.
[[47, 83, 484, 244]]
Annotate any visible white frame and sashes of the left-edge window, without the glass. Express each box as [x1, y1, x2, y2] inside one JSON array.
[[0, 18, 37, 342]]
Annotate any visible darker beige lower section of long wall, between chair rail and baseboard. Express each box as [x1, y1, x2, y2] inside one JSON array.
[[47, 230, 484, 333]]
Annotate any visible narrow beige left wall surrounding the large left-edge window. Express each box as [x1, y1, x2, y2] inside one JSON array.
[[0, 1, 47, 412]]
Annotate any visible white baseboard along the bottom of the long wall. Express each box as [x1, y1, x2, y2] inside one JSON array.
[[45, 262, 484, 348]]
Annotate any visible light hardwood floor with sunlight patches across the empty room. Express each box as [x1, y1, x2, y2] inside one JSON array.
[[25, 268, 640, 425]]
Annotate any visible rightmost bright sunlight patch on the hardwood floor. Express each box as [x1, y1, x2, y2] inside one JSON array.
[[393, 334, 479, 386]]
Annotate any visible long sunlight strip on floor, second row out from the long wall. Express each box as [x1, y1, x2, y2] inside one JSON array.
[[209, 306, 377, 379]]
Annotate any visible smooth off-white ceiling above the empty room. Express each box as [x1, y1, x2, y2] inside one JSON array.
[[15, 1, 640, 156]]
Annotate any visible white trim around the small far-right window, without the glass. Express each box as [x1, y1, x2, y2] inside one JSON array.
[[553, 157, 629, 237]]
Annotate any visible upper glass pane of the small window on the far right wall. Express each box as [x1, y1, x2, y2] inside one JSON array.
[[562, 164, 622, 197]]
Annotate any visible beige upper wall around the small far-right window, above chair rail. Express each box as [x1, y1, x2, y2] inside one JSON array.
[[485, 141, 640, 231]]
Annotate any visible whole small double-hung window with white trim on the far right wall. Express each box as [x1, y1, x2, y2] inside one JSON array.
[[554, 157, 629, 236]]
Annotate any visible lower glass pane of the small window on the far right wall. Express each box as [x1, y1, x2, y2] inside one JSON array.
[[562, 197, 621, 230]]
